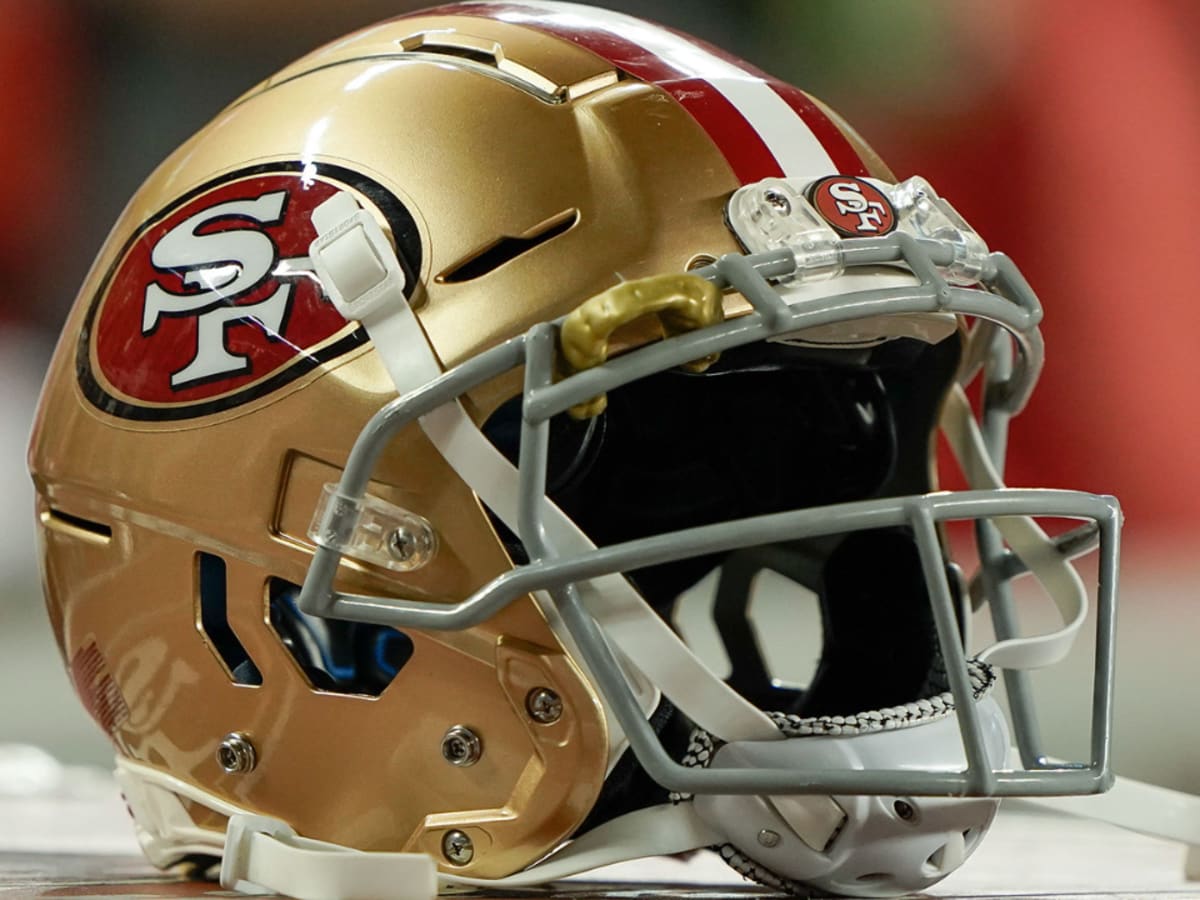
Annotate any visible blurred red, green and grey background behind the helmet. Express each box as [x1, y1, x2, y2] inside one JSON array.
[[0, 0, 1200, 792]]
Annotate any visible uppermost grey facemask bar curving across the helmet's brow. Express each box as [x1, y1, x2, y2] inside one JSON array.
[[314, 217, 1044, 498]]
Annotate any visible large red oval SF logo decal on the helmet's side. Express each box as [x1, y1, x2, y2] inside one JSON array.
[[78, 163, 420, 420]]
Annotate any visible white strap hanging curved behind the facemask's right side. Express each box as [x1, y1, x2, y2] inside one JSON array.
[[942, 385, 1087, 668]]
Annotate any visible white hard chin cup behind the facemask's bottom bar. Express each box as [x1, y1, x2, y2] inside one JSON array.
[[695, 697, 1009, 896]]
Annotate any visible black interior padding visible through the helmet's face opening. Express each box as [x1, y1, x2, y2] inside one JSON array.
[[485, 336, 961, 821]]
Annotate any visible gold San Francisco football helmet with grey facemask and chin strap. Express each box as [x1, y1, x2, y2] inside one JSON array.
[[30, 0, 1120, 896]]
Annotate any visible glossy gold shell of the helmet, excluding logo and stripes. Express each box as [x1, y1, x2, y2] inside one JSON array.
[[30, 7, 892, 877]]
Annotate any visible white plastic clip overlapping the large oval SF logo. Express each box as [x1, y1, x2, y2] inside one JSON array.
[[308, 191, 408, 322]]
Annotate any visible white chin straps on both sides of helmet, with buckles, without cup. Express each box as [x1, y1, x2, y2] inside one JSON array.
[[292, 192, 1152, 898]]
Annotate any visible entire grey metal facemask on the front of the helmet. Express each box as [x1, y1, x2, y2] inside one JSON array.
[[299, 233, 1120, 796]]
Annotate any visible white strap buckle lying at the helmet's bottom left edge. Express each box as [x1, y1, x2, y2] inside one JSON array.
[[221, 815, 438, 900]]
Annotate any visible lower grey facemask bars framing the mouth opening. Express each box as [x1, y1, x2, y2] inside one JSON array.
[[307, 468, 1120, 796]]
